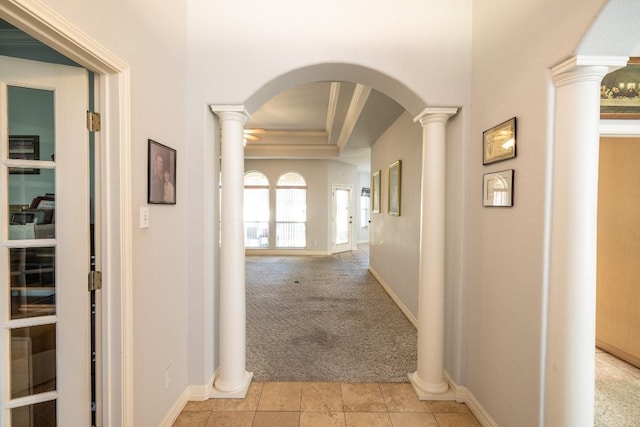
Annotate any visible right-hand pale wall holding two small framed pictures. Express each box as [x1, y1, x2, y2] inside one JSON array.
[[465, 0, 604, 426]]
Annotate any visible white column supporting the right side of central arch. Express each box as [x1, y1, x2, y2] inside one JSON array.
[[409, 108, 458, 400]]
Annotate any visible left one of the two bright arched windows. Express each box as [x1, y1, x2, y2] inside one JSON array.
[[244, 171, 269, 248]]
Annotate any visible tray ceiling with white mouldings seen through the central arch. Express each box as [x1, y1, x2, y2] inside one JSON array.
[[245, 82, 404, 171]]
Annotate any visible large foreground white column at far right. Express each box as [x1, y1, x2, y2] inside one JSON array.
[[544, 57, 626, 426]]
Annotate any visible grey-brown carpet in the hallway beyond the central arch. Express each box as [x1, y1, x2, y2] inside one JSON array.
[[246, 247, 417, 382]]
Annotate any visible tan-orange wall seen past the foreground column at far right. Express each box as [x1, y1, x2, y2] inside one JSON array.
[[596, 138, 640, 366]]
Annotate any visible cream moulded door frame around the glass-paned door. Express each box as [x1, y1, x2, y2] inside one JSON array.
[[0, 0, 134, 425]]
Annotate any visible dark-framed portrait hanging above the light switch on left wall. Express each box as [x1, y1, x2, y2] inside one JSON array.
[[147, 139, 176, 205]]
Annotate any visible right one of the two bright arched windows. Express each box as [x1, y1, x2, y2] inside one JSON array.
[[276, 172, 307, 248]]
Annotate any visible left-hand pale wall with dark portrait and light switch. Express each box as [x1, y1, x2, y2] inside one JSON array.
[[38, 0, 190, 425]]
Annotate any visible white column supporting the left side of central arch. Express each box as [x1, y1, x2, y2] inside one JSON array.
[[211, 105, 253, 398]]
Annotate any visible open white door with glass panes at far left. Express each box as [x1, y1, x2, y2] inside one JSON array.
[[0, 57, 91, 427]]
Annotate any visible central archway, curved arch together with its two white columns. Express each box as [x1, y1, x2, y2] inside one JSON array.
[[211, 64, 457, 400]]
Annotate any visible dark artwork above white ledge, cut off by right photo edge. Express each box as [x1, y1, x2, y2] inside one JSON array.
[[600, 57, 640, 119]]
